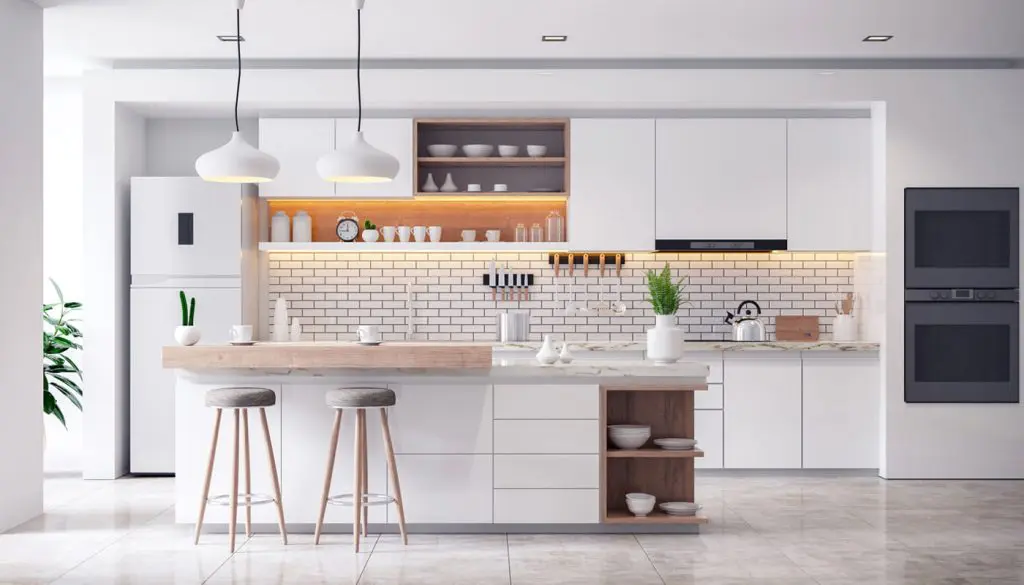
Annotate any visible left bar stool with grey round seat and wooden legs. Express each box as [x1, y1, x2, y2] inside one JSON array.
[[196, 388, 288, 552]]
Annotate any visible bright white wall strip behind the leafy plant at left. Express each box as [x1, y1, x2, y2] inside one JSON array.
[[43, 78, 89, 471]]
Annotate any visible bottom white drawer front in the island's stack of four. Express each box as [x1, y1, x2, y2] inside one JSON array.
[[495, 490, 600, 525]]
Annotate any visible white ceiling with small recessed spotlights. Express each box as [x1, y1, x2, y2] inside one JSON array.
[[44, 0, 1024, 75]]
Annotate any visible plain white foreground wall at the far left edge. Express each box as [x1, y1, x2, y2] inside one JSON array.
[[0, 0, 43, 532]]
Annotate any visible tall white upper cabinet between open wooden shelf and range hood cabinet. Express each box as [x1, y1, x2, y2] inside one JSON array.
[[568, 119, 655, 251]]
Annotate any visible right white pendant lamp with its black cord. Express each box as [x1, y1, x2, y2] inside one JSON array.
[[316, 0, 398, 182]]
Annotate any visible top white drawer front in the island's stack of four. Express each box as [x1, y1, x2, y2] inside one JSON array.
[[495, 385, 601, 420]]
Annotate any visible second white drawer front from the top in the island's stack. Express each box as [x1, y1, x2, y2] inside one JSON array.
[[495, 420, 601, 454]]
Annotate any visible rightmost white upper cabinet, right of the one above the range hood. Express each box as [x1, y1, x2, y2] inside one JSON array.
[[788, 119, 872, 250]]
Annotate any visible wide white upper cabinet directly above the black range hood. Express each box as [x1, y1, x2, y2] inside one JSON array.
[[651, 119, 786, 240]]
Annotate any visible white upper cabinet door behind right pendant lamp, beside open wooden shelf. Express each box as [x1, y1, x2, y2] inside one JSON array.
[[335, 118, 415, 199]]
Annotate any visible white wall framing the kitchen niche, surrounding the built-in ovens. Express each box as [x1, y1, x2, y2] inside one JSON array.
[[86, 70, 1024, 477]]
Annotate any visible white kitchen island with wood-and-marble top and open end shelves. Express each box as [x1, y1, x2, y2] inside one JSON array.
[[164, 343, 710, 533]]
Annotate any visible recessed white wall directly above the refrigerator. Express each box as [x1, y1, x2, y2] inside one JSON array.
[[145, 118, 259, 176]]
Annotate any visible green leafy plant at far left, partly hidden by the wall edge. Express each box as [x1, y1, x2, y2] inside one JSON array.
[[43, 279, 83, 428]]
